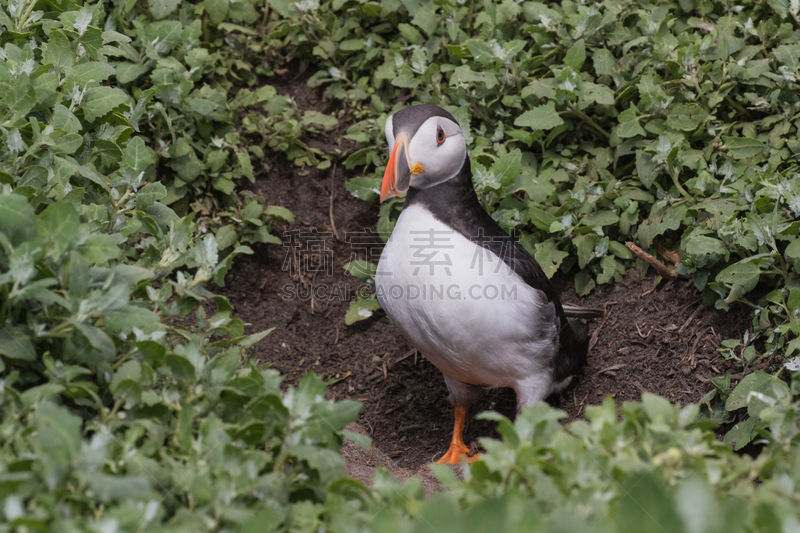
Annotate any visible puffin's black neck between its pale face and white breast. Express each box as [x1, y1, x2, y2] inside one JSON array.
[[403, 158, 484, 236]]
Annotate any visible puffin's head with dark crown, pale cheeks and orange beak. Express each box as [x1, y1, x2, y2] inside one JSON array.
[[381, 104, 467, 202]]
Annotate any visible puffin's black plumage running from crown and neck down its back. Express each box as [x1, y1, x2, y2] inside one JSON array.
[[406, 158, 589, 383]]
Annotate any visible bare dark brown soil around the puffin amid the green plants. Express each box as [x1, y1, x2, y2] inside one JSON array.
[[219, 70, 749, 482]]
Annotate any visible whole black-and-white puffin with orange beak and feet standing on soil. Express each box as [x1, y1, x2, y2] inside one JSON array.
[[375, 104, 603, 464]]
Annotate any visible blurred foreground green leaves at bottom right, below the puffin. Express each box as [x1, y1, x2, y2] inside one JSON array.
[[312, 386, 798, 533]]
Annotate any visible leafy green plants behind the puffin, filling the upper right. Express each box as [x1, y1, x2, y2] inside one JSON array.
[[267, 1, 800, 366]]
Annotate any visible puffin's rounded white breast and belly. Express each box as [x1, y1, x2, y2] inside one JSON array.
[[375, 205, 558, 388]]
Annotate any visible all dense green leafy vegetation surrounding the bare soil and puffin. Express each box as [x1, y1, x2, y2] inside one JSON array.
[[0, 0, 800, 533]]
